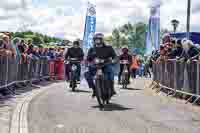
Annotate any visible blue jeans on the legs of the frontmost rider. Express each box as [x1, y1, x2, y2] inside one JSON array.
[[85, 65, 114, 89]]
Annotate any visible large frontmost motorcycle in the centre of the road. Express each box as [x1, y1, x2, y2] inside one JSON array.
[[95, 59, 112, 109]]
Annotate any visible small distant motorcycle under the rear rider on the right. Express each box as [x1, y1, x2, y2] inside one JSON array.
[[120, 60, 129, 89]]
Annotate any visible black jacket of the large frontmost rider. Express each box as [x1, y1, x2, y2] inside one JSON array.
[[87, 44, 117, 61]]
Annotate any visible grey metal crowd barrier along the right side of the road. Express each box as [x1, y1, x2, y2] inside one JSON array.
[[152, 59, 200, 103]]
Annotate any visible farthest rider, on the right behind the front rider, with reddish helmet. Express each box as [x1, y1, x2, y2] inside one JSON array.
[[118, 47, 132, 84]]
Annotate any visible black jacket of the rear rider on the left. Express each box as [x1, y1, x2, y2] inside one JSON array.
[[65, 47, 84, 61]]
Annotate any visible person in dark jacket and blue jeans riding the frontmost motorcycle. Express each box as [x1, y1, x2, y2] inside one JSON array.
[[85, 33, 117, 98]]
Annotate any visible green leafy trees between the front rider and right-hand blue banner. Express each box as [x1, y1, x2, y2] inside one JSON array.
[[106, 22, 147, 54]]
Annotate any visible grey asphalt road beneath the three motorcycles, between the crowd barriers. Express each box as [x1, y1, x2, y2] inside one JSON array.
[[28, 80, 200, 133]]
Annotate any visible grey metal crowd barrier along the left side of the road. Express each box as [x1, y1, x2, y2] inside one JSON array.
[[0, 55, 64, 91]]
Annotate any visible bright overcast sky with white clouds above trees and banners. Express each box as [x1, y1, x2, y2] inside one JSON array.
[[0, 0, 200, 39]]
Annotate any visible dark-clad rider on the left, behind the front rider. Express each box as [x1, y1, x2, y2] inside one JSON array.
[[65, 41, 84, 81]]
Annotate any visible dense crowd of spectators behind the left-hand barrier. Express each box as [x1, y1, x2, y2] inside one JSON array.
[[0, 34, 64, 62]]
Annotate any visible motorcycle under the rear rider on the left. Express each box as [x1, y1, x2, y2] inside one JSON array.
[[67, 58, 80, 92]]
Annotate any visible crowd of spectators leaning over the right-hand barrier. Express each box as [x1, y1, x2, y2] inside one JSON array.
[[151, 34, 200, 63]]
